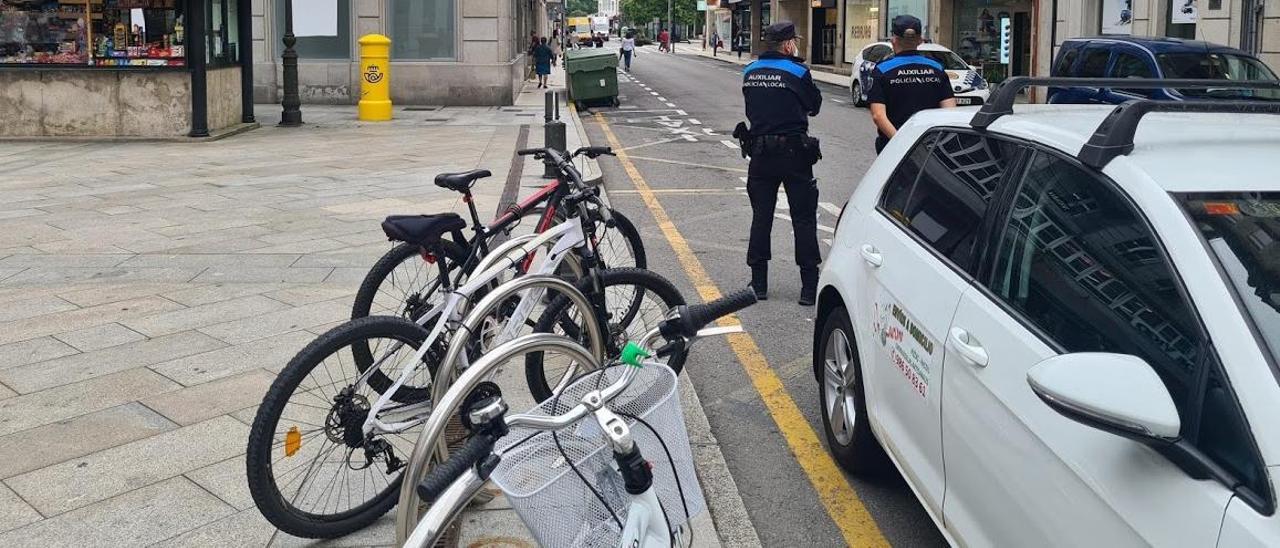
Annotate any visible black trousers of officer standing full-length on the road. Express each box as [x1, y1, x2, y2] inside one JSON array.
[[746, 156, 822, 268]]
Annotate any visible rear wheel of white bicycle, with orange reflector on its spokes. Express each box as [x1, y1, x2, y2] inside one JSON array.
[[244, 316, 434, 538]]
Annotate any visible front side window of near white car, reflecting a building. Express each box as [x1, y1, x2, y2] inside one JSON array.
[[987, 152, 1204, 424]]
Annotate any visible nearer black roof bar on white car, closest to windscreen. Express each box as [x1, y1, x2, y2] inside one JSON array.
[[1076, 100, 1280, 169]]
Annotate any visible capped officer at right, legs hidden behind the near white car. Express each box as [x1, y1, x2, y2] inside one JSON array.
[[867, 15, 956, 154]]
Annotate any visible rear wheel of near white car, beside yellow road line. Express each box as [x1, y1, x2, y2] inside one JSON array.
[[814, 306, 887, 476]]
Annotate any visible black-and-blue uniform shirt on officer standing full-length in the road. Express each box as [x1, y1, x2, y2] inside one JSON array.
[[742, 51, 822, 136]]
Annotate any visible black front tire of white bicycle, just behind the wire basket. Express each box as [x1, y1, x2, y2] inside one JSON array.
[[525, 268, 686, 402]]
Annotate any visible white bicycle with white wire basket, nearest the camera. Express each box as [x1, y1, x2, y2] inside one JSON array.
[[397, 289, 755, 548]]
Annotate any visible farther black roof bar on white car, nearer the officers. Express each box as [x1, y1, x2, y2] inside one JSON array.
[[969, 76, 1280, 131]]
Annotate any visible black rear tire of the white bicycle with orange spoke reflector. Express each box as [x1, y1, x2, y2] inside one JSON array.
[[244, 316, 434, 538]]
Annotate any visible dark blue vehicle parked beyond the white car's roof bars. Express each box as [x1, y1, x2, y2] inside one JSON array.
[[1048, 37, 1280, 105]]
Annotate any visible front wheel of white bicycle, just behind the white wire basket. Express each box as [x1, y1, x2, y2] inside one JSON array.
[[525, 269, 685, 402]]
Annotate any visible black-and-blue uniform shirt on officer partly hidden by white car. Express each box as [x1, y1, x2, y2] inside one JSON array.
[[867, 51, 955, 138]]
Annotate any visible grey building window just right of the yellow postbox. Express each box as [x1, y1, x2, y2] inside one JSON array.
[[388, 0, 453, 60]]
